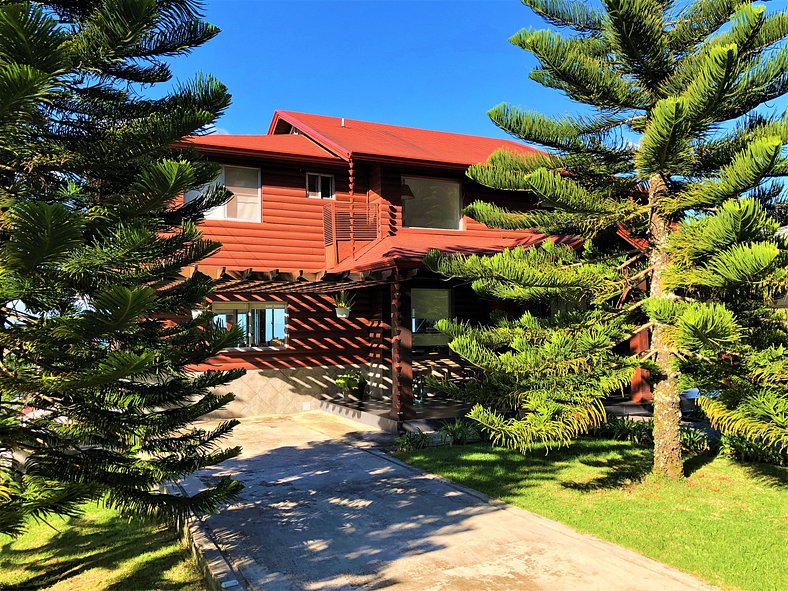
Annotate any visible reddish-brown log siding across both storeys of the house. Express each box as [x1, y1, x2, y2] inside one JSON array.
[[191, 158, 540, 384]]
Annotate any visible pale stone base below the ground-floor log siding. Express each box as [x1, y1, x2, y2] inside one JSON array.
[[208, 365, 390, 418]]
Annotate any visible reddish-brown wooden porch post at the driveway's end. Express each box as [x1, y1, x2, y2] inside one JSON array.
[[389, 281, 416, 421]]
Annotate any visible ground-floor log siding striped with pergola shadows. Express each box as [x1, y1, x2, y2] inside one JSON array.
[[197, 290, 374, 371]]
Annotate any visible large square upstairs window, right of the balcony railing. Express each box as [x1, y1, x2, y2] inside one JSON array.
[[402, 177, 462, 230]]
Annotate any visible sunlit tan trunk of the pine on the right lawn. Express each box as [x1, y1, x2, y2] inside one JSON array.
[[649, 175, 684, 479]]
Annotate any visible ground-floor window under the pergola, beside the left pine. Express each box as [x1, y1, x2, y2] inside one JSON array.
[[213, 302, 287, 347]]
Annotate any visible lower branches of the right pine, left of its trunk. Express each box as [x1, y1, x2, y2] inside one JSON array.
[[426, 241, 659, 452]]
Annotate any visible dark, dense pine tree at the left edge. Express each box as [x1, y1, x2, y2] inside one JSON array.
[[0, 0, 242, 534]]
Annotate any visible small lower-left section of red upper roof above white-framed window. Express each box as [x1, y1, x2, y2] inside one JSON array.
[[184, 133, 339, 160]]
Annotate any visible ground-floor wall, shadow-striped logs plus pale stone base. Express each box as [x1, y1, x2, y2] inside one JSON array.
[[194, 285, 396, 418]]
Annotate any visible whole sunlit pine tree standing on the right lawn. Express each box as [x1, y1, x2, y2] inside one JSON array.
[[427, 0, 788, 477]]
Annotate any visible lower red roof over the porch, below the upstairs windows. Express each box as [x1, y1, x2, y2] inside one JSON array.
[[327, 231, 556, 273]]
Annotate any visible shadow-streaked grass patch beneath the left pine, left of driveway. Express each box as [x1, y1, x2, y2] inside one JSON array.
[[0, 505, 205, 591]]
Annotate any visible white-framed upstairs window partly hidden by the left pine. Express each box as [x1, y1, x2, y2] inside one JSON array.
[[184, 165, 262, 222]]
